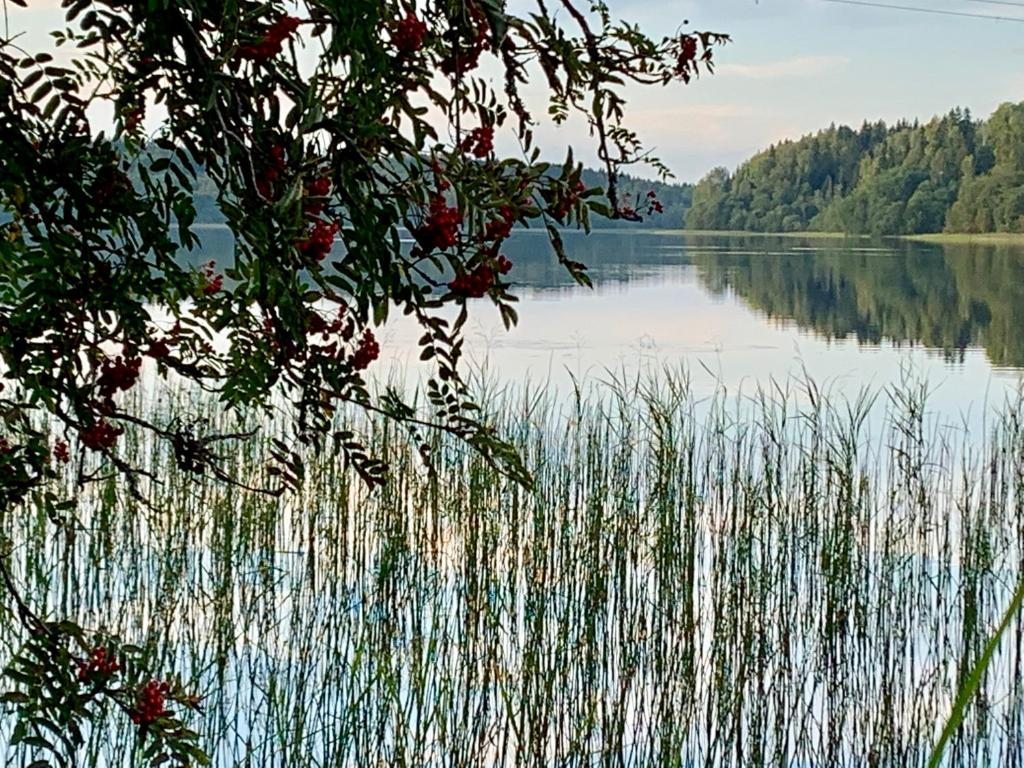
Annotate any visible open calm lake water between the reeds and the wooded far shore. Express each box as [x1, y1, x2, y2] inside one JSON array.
[[186, 229, 1024, 428]]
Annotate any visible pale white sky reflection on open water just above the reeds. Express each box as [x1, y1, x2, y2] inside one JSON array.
[[372, 253, 1020, 430]]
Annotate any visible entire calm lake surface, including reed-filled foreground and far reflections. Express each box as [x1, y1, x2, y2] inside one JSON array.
[[0, 230, 1024, 768]]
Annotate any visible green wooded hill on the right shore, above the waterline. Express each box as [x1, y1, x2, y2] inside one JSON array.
[[685, 103, 1024, 234]]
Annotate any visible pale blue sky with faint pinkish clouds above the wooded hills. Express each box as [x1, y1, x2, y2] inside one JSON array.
[[11, 0, 1024, 181]]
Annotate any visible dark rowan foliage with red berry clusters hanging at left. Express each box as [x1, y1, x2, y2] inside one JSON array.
[[0, 0, 727, 763]]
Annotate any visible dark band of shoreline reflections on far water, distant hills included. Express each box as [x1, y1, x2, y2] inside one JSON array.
[[493, 232, 1024, 368]]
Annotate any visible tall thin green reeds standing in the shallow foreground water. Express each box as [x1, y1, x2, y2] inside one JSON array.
[[0, 374, 1024, 768]]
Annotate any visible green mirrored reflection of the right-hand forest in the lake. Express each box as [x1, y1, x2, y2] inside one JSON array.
[[692, 245, 1024, 367]]
